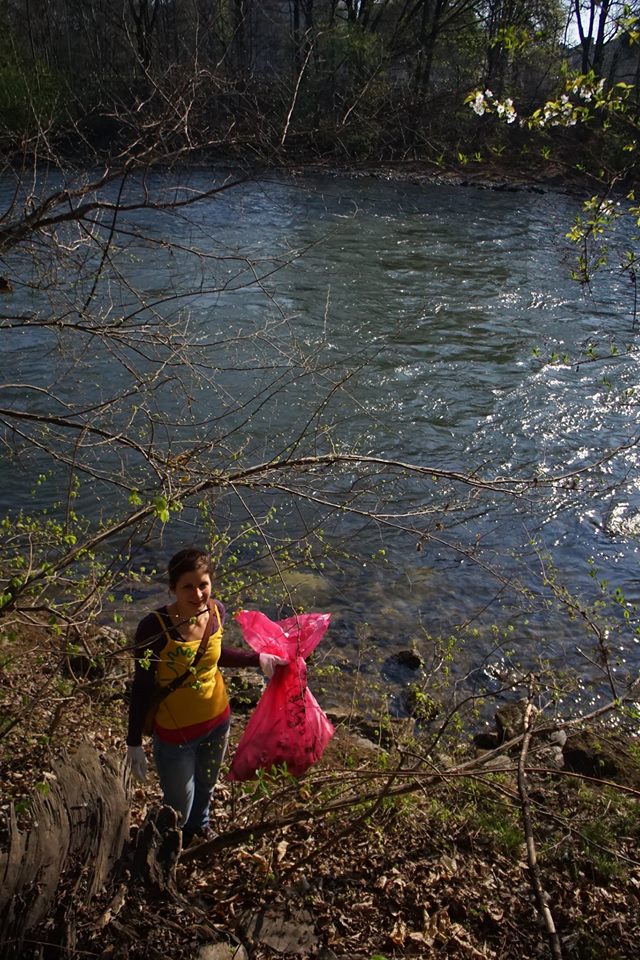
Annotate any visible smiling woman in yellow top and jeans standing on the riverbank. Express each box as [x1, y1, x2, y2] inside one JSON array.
[[127, 548, 286, 846]]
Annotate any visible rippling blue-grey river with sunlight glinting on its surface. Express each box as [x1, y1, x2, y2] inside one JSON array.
[[2, 171, 640, 724]]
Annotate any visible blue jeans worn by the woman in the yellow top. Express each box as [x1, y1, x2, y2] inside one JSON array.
[[153, 720, 229, 833]]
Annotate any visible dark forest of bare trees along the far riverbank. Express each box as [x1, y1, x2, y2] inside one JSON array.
[[0, 0, 640, 175]]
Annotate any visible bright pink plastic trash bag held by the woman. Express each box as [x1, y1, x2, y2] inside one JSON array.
[[228, 610, 334, 780]]
